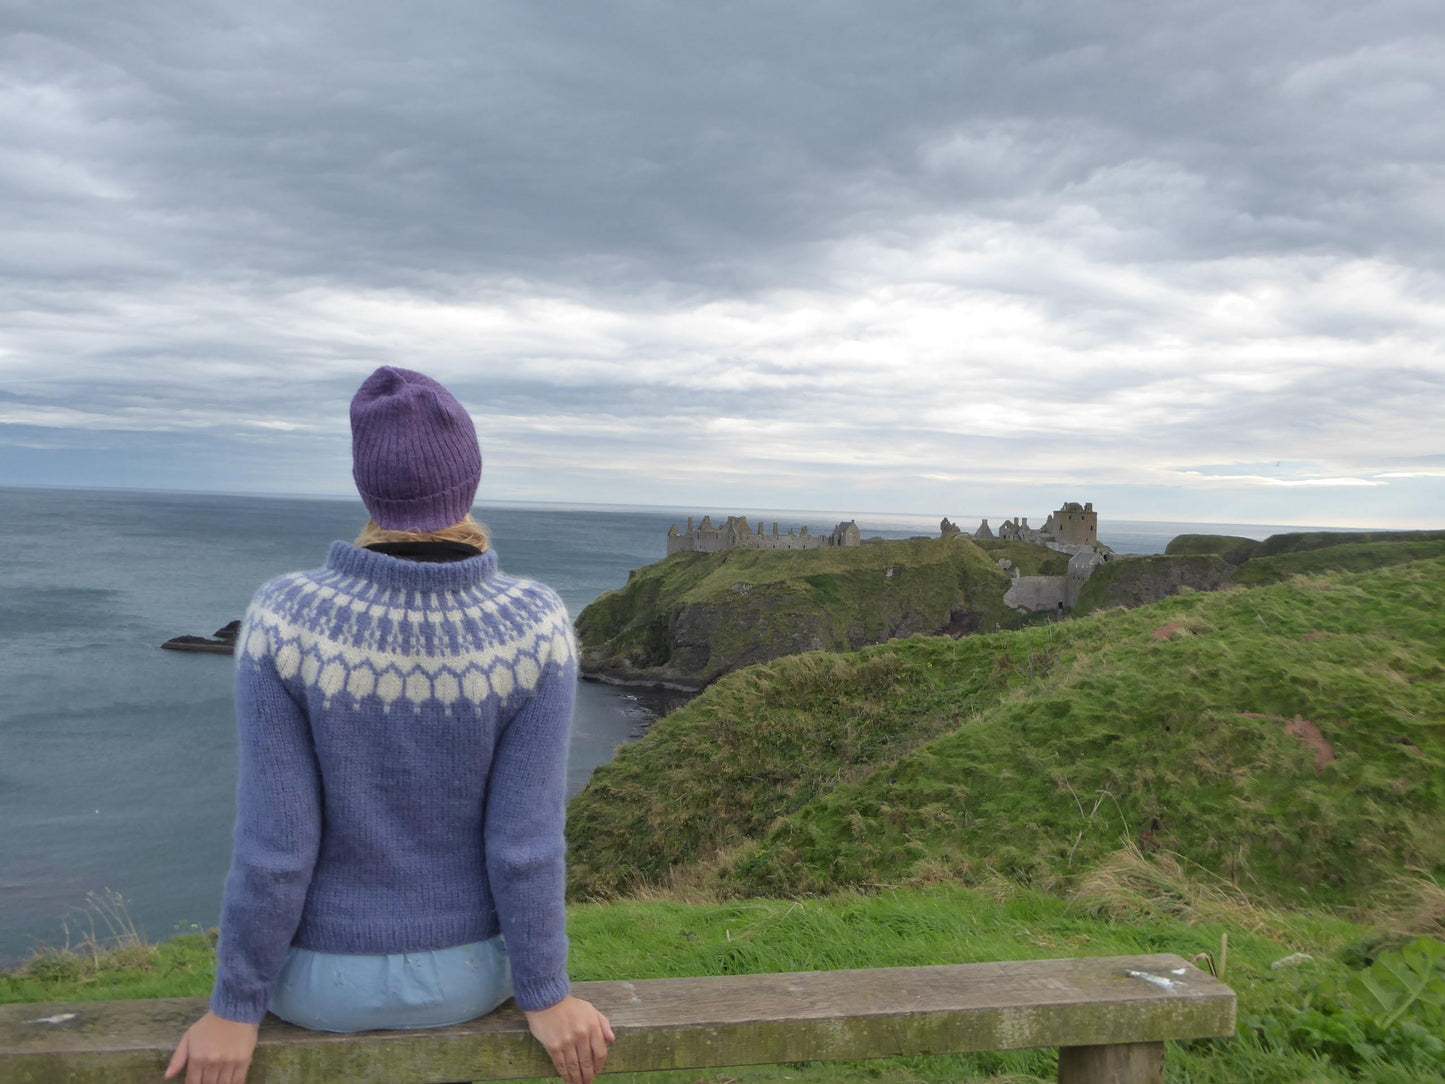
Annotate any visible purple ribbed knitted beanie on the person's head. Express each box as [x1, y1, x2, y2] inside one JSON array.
[[351, 366, 481, 530]]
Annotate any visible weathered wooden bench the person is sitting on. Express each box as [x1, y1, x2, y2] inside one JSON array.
[[0, 955, 1235, 1084]]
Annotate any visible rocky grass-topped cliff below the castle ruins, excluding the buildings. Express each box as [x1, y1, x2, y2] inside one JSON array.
[[577, 535, 1017, 688]]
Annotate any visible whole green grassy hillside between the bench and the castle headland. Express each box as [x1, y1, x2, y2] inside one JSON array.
[[569, 558, 1445, 906]]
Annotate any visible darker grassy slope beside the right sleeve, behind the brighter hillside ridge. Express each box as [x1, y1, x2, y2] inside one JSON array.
[[568, 636, 1042, 898]]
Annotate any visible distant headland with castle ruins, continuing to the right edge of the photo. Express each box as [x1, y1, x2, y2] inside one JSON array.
[[577, 502, 1445, 691]]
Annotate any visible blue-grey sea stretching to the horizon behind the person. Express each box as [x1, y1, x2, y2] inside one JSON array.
[[0, 487, 1329, 964]]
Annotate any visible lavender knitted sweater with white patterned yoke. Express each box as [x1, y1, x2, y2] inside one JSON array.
[[211, 542, 577, 1023]]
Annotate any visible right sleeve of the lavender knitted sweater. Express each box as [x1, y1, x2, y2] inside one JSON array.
[[484, 601, 577, 1012]]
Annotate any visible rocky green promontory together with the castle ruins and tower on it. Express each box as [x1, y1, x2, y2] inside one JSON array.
[[577, 502, 1113, 689]]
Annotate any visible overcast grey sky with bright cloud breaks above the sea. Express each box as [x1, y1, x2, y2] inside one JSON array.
[[0, 0, 1445, 526]]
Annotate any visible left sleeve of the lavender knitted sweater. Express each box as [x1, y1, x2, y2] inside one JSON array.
[[211, 603, 321, 1023]]
